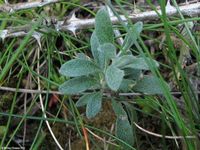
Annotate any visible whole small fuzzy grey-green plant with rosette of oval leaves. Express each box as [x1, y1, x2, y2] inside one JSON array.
[[59, 8, 168, 148]]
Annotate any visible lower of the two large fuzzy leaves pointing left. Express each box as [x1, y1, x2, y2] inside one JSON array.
[[59, 76, 98, 94]]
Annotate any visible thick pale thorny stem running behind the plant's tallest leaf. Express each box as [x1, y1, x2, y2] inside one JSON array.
[[0, 0, 200, 39]]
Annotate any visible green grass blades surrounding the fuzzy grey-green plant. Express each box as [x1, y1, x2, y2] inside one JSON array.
[[0, 0, 200, 150]]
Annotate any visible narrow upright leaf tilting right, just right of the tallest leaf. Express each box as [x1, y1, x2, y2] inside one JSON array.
[[123, 22, 143, 50]]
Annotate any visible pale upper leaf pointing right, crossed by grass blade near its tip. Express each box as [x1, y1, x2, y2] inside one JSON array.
[[125, 57, 159, 70]]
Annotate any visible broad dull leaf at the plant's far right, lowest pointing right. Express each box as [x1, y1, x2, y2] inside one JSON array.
[[133, 75, 167, 94]]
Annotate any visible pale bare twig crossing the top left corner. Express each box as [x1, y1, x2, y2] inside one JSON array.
[[0, 0, 60, 13]]
